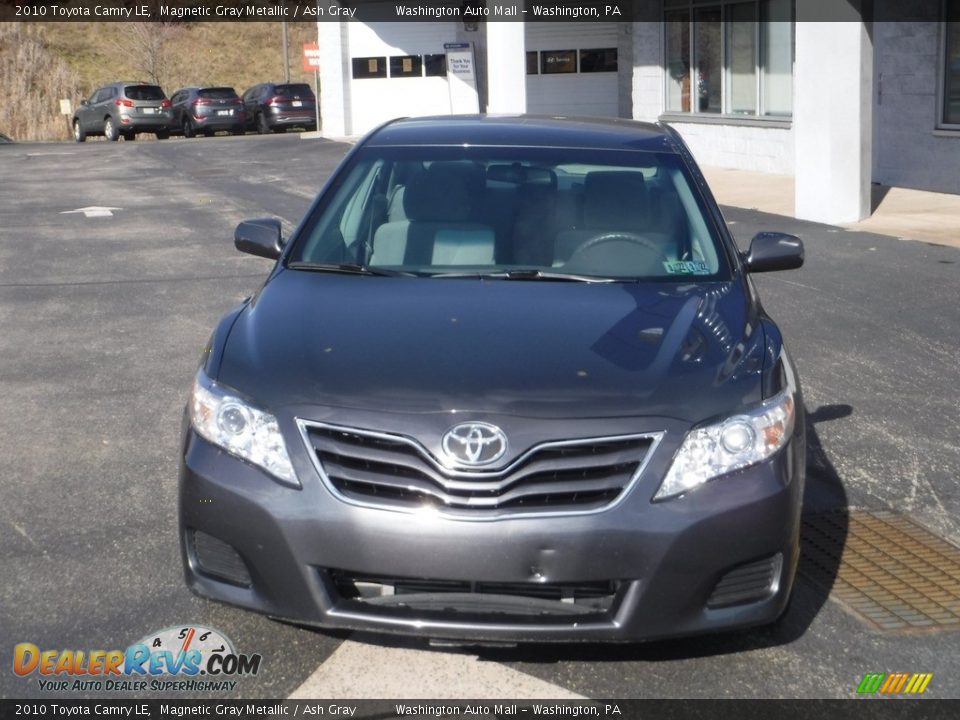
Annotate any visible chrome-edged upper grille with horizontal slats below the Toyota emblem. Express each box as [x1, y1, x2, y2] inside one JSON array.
[[301, 423, 657, 516]]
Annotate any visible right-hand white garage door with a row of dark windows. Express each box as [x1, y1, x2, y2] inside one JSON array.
[[525, 22, 619, 117]]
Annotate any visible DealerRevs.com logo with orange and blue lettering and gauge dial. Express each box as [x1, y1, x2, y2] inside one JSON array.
[[13, 625, 262, 692]]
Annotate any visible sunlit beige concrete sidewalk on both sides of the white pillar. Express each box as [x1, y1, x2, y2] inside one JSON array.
[[702, 167, 960, 247]]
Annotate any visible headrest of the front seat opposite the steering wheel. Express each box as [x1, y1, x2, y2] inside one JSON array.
[[403, 162, 485, 222]]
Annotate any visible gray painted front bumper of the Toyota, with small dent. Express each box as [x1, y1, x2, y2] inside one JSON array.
[[180, 410, 804, 642]]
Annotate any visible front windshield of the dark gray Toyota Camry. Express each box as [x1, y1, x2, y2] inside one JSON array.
[[287, 146, 730, 282]]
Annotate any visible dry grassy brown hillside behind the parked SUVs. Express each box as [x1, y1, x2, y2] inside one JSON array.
[[0, 22, 317, 140]]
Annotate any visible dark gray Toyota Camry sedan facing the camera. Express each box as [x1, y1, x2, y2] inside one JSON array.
[[180, 116, 805, 642]]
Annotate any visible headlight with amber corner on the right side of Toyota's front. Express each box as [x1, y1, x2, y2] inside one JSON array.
[[653, 388, 796, 500]]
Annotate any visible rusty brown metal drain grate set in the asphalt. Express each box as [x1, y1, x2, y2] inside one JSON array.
[[800, 510, 960, 630]]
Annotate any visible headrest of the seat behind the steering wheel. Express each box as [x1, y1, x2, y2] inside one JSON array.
[[583, 170, 647, 230]]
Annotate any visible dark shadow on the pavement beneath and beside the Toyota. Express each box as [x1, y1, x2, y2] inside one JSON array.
[[304, 405, 853, 664]]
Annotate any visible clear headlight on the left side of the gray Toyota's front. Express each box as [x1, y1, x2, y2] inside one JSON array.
[[190, 370, 300, 487]]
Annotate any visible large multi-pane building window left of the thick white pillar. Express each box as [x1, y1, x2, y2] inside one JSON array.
[[664, 0, 792, 117]]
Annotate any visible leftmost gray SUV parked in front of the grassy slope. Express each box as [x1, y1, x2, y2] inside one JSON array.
[[71, 82, 173, 142]]
